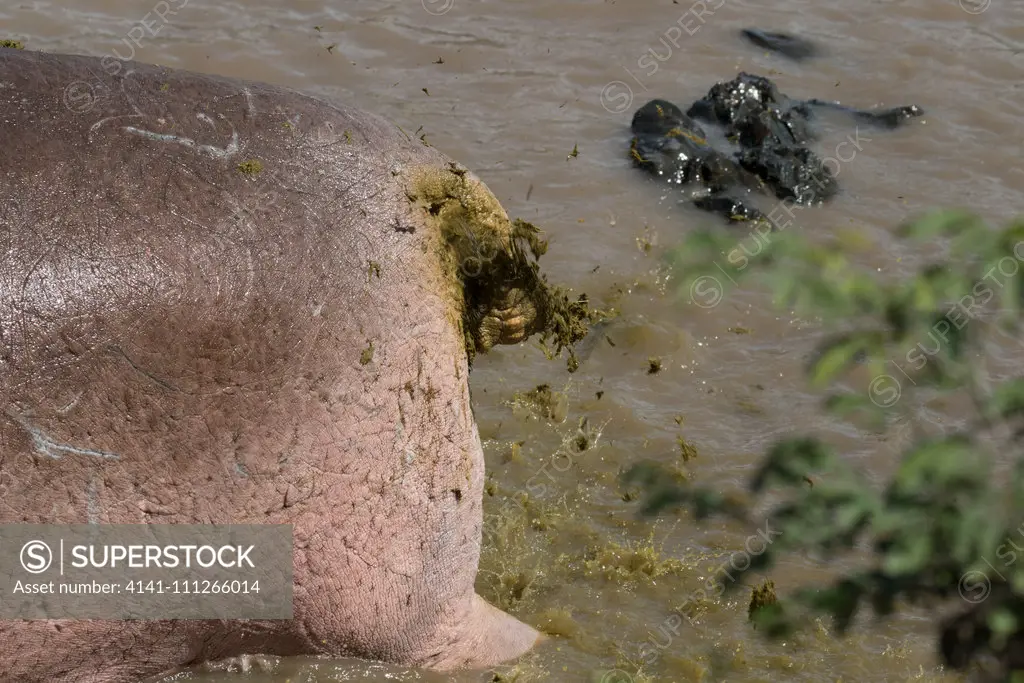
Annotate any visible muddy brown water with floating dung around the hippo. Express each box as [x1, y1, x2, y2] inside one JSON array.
[[0, 0, 1024, 683]]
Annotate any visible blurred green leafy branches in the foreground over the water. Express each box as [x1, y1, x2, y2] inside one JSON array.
[[625, 211, 1024, 681]]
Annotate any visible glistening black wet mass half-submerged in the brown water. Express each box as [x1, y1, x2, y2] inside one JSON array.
[[630, 29, 924, 222]]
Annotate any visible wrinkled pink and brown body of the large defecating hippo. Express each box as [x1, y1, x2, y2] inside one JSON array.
[[0, 49, 538, 683]]
